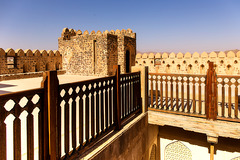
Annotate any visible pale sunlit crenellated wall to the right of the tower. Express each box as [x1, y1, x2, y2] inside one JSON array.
[[135, 51, 240, 75]]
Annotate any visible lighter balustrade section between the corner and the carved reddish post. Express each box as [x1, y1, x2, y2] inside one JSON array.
[[149, 73, 206, 117]]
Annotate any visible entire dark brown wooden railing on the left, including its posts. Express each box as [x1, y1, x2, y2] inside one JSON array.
[[0, 66, 141, 160]]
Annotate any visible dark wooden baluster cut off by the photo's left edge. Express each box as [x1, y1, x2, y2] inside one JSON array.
[[0, 121, 7, 160]]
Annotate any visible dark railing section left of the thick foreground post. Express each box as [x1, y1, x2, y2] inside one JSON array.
[[0, 88, 45, 160]]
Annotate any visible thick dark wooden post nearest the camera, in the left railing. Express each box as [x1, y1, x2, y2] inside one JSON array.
[[41, 71, 61, 160]]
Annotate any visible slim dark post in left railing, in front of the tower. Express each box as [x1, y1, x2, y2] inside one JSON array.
[[113, 65, 121, 130]]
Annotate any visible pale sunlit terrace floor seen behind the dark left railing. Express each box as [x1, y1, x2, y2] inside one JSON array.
[[0, 74, 99, 94]]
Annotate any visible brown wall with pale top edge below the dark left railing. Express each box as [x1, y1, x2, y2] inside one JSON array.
[[78, 113, 159, 160]]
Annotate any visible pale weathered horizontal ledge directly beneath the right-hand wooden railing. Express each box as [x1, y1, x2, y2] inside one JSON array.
[[148, 111, 240, 139]]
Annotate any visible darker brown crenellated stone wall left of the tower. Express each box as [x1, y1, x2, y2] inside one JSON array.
[[0, 48, 62, 75]]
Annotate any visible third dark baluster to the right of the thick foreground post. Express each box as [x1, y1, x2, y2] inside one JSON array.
[[79, 95, 83, 148]]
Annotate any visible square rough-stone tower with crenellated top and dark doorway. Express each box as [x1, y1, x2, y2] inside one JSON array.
[[58, 28, 136, 76]]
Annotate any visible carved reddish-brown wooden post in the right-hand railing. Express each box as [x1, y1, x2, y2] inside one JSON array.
[[205, 62, 217, 120]]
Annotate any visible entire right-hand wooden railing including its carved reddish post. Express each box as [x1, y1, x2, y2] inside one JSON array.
[[149, 62, 240, 122]]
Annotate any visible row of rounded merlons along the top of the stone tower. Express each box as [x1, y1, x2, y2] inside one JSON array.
[[59, 28, 136, 40]]
